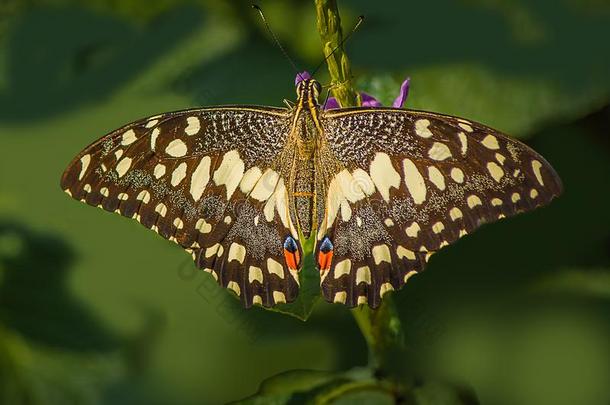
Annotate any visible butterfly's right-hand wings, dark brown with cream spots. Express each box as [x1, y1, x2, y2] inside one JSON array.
[[316, 108, 562, 307]]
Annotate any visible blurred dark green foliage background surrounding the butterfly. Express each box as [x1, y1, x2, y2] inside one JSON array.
[[0, 0, 610, 405]]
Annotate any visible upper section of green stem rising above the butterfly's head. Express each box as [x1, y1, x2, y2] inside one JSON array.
[[315, 0, 360, 107]]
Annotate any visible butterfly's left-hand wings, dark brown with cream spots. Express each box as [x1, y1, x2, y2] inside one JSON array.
[[61, 107, 300, 307]]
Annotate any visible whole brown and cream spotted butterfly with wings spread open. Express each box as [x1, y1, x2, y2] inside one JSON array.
[[61, 78, 562, 308]]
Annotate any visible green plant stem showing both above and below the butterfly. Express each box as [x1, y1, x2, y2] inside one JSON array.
[[315, 0, 404, 374]]
